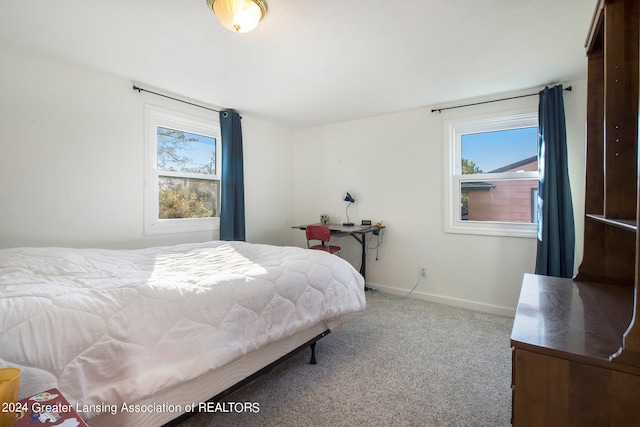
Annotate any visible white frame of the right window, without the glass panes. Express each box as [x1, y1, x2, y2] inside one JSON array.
[[444, 110, 539, 238]]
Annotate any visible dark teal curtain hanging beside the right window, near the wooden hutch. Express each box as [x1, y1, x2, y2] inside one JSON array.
[[536, 85, 575, 277]]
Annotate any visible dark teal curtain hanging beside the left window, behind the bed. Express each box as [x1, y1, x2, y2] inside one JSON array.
[[220, 110, 245, 241]]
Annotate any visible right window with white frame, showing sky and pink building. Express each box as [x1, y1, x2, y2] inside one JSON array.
[[445, 112, 538, 237]]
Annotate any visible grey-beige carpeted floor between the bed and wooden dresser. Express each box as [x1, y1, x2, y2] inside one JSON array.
[[180, 292, 513, 427]]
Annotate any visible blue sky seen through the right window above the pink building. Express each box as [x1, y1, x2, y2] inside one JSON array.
[[461, 127, 538, 173]]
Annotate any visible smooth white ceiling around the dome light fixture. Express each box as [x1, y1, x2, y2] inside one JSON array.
[[0, 0, 596, 128]]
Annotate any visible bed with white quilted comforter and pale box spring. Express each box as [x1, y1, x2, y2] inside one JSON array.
[[0, 241, 366, 427]]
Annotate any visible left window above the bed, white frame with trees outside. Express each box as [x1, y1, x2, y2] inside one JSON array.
[[145, 105, 221, 234]]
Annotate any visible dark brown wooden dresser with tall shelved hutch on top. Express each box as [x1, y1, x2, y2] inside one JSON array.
[[511, 0, 640, 427]]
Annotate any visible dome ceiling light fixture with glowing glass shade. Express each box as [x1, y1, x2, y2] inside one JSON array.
[[207, 0, 267, 33]]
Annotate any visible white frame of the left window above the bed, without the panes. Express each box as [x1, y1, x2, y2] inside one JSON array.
[[144, 104, 222, 235]]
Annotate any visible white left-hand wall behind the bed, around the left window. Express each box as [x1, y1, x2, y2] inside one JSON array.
[[0, 42, 293, 247]]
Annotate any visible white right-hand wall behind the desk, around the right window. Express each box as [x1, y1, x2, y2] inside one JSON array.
[[293, 81, 586, 314]]
